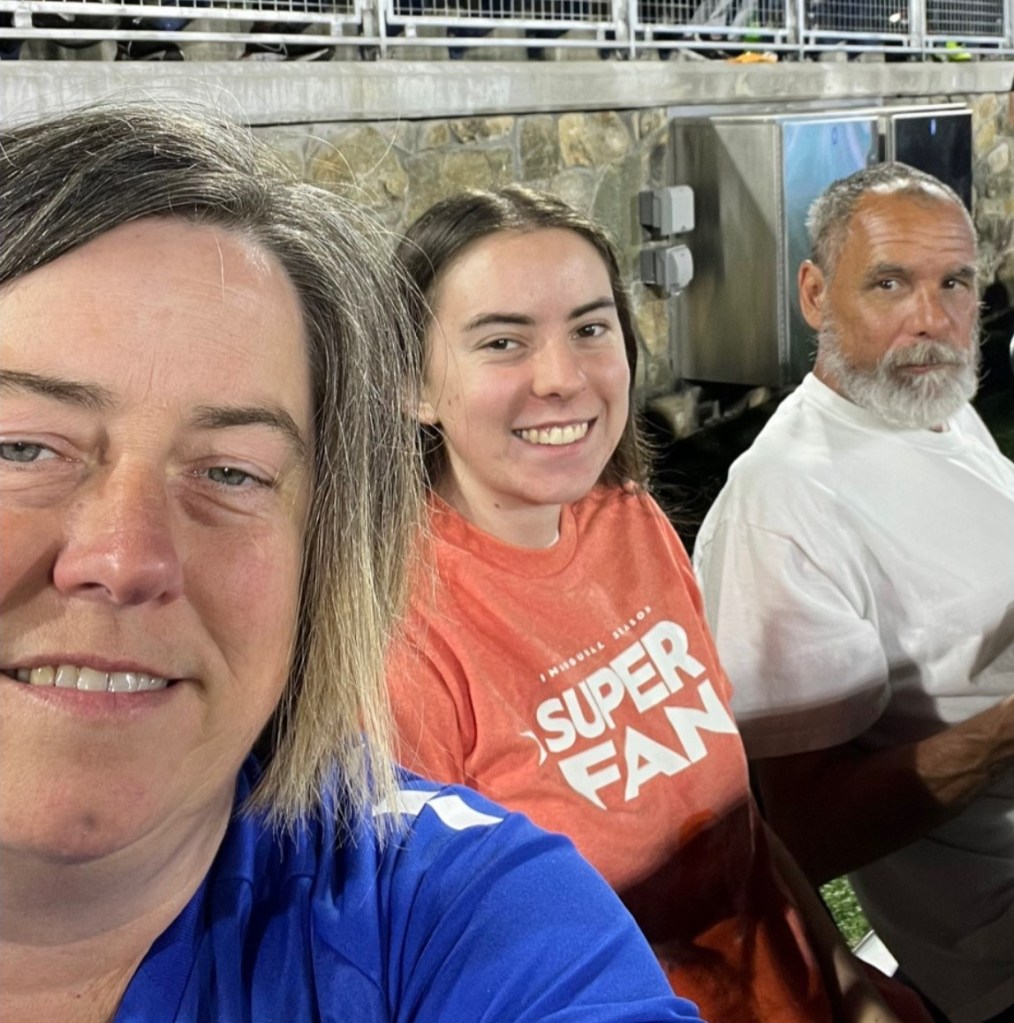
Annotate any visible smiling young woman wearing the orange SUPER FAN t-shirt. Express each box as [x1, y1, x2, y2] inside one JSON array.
[[388, 186, 937, 1023]]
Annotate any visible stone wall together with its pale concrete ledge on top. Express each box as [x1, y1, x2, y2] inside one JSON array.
[[0, 60, 1014, 403]]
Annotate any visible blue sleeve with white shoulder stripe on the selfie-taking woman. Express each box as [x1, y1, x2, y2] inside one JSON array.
[[382, 789, 700, 1023]]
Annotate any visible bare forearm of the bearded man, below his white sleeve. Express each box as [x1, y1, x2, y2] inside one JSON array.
[[752, 696, 1014, 884]]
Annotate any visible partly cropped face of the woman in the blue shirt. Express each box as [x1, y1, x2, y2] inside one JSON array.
[[0, 220, 312, 863]]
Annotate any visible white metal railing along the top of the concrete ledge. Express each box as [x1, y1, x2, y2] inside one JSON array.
[[0, 0, 1014, 59]]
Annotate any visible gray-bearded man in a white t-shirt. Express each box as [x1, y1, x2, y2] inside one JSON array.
[[695, 164, 1014, 1023]]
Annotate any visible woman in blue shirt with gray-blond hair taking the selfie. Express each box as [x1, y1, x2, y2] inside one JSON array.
[[0, 106, 698, 1023]]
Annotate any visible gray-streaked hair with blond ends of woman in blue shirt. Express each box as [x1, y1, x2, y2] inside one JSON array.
[[0, 105, 421, 827]]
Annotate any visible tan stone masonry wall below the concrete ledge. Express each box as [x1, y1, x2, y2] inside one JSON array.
[[261, 87, 1014, 400]]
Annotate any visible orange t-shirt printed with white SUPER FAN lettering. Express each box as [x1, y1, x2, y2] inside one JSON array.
[[389, 488, 831, 1023]]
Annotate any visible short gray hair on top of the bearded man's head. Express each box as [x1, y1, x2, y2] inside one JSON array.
[[806, 161, 976, 279]]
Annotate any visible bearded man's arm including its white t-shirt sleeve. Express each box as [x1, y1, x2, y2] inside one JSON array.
[[698, 524, 1014, 883]]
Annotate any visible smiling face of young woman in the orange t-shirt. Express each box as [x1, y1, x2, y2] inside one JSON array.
[[420, 228, 630, 546]]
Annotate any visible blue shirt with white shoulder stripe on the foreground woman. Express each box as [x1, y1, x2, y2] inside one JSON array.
[[116, 761, 699, 1023]]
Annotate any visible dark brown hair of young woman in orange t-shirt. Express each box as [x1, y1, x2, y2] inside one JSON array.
[[396, 185, 648, 486]]
